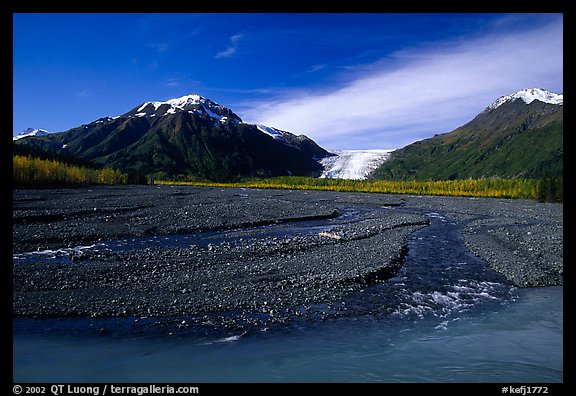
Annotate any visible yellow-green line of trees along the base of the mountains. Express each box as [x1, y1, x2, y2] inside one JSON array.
[[12, 155, 564, 202]]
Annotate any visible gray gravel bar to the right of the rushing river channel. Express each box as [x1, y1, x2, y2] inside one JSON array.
[[398, 197, 564, 287]]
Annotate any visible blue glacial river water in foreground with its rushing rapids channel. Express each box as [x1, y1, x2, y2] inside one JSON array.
[[13, 213, 563, 383]]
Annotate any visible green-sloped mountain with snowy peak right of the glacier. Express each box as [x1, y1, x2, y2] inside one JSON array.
[[371, 88, 564, 180]]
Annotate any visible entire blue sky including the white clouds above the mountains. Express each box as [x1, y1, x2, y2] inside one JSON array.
[[13, 13, 563, 149]]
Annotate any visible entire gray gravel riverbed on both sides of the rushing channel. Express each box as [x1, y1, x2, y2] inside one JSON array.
[[13, 186, 563, 332]]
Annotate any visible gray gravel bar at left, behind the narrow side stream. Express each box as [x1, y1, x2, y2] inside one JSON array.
[[13, 186, 336, 253]]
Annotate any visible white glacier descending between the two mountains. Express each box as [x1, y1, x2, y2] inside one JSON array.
[[320, 149, 393, 180]]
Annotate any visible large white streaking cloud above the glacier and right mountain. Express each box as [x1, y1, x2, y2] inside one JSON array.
[[242, 18, 563, 149]]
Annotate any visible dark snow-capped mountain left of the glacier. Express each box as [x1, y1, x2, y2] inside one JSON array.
[[16, 94, 330, 181]]
